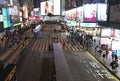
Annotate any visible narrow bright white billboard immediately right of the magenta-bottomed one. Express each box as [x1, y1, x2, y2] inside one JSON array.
[[97, 4, 107, 21]]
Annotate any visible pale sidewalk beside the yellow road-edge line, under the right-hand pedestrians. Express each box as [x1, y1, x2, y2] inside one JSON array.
[[88, 45, 120, 79]]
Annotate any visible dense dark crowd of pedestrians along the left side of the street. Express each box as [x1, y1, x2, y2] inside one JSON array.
[[0, 27, 29, 49]]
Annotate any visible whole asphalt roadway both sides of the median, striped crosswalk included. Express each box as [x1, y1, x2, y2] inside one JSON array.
[[17, 24, 117, 81]]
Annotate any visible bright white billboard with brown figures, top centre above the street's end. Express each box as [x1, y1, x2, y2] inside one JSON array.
[[41, 0, 60, 15]]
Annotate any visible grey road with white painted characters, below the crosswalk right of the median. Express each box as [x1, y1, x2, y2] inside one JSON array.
[[64, 51, 116, 81]]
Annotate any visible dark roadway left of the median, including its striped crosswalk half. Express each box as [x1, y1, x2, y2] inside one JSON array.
[[17, 32, 55, 81]]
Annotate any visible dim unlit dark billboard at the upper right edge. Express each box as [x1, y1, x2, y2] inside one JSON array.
[[109, 5, 120, 22]]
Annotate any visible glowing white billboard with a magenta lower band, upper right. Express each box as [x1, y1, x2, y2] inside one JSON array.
[[84, 4, 97, 22]]
